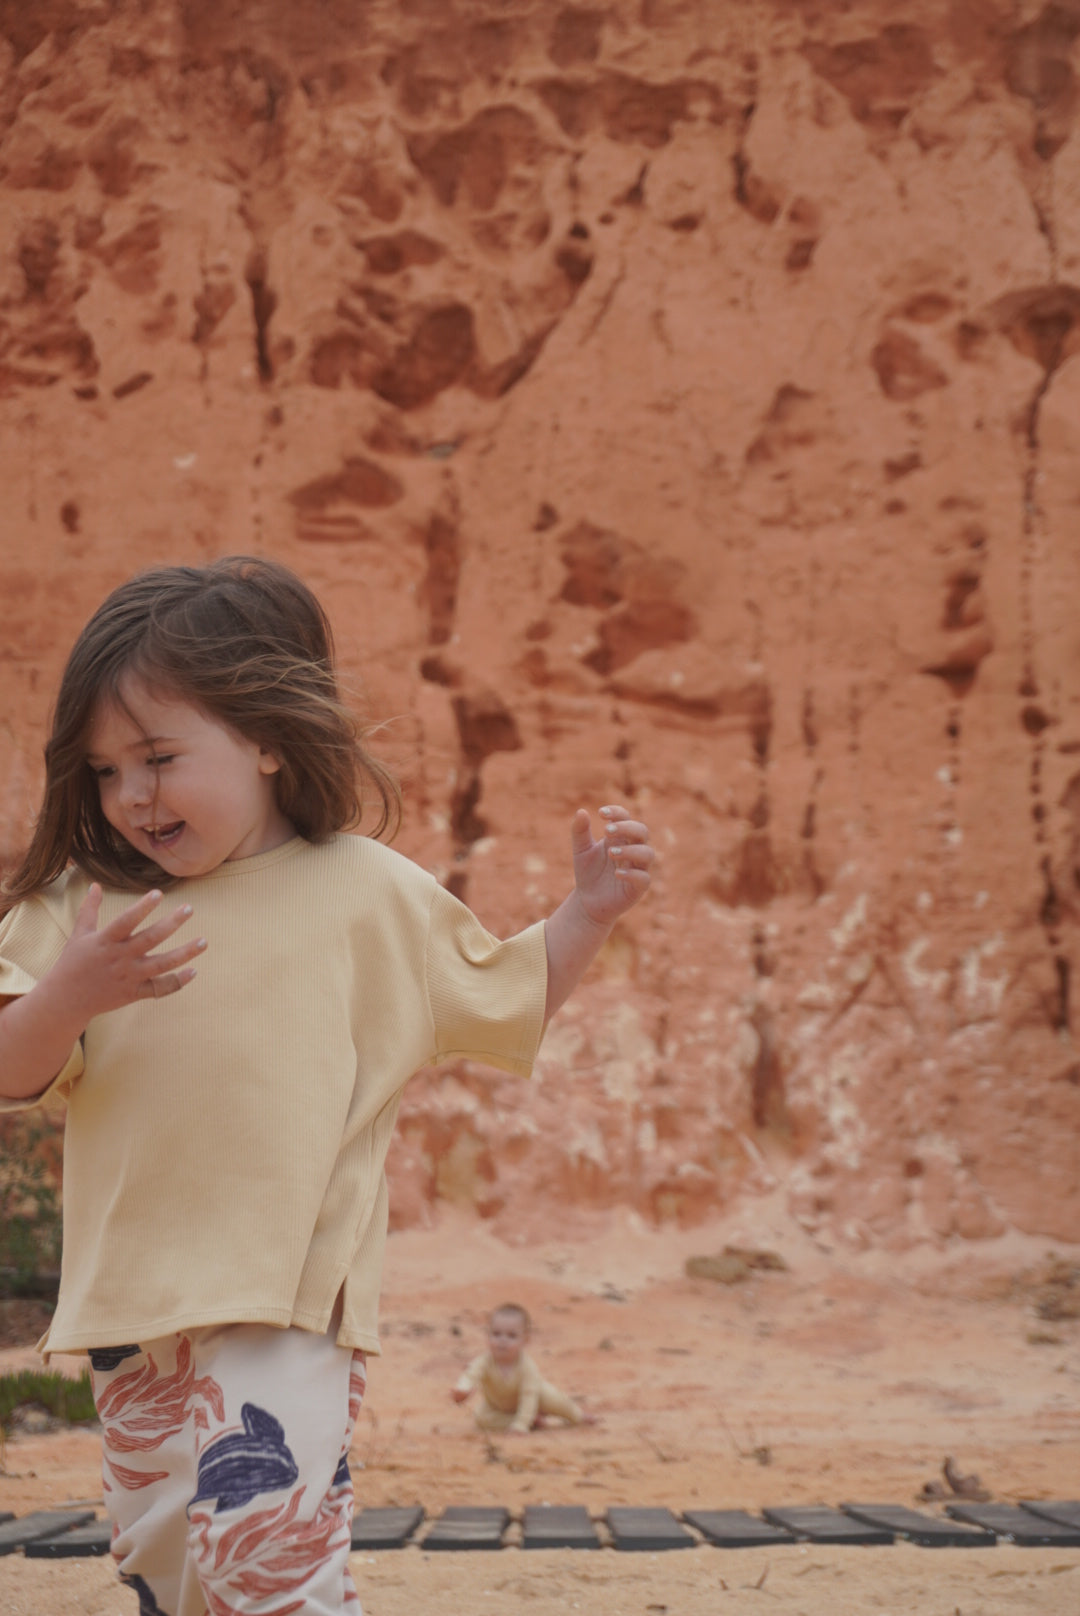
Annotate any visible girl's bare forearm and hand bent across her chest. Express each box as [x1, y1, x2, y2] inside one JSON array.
[[0, 884, 205, 1100]]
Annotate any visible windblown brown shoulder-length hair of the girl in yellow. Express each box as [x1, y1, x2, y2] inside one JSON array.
[[0, 556, 401, 908]]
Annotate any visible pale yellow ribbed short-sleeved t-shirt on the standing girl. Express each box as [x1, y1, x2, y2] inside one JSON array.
[[0, 835, 546, 1353]]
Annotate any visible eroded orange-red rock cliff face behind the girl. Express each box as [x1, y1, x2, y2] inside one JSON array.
[[0, 0, 1080, 1244]]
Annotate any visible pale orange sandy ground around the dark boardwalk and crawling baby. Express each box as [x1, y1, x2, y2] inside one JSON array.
[[0, 1204, 1080, 1616]]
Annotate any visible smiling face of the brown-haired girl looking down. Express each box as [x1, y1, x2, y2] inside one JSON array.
[[87, 675, 294, 879]]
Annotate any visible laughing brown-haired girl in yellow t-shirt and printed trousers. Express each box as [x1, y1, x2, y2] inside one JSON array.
[[0, 558, 653, 1616]]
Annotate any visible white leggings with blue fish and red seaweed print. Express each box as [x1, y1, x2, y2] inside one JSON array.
[[91, 1324, 365, 1616]]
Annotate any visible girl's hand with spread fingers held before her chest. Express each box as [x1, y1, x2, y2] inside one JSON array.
[[49, 882, 207, 1025]]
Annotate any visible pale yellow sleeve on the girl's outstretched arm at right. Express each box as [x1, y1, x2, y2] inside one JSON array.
[[427, 886, 548, 1078]]
